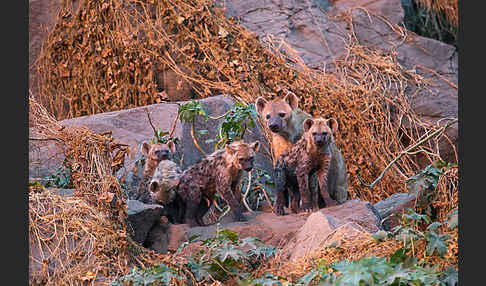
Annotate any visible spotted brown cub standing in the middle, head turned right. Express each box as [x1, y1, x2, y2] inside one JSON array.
[[178, 141, 260, 226]]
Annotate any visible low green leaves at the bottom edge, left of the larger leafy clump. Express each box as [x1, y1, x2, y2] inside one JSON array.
[[110, 263, 185, 286]]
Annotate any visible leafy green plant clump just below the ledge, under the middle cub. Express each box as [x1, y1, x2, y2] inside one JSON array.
[[180, 228, 275, 282]]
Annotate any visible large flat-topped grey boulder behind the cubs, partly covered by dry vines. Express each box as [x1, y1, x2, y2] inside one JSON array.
[[29, 95, 273, 188]]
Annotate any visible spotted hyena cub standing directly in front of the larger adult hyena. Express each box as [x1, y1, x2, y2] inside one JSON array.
[[275, 118, 338, 215]]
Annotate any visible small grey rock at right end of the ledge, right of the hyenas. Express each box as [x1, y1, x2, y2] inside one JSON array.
[[374, 193, 417, 231]]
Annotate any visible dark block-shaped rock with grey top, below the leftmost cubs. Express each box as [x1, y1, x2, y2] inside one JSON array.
[[127, 200, 163, 245]]
